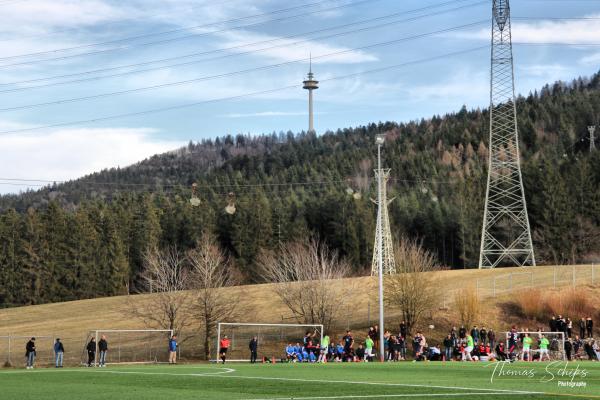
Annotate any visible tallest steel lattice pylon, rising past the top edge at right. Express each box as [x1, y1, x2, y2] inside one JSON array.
[[479, 0, 535, 268]]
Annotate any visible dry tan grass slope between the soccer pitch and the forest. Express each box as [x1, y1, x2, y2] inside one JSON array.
[[0, 266, 600, 363]]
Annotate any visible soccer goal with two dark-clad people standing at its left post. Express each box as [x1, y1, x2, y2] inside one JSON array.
[[81, 329, 173, 365]]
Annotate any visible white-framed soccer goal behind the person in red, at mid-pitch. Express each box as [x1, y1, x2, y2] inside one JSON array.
[[211, 322, 323, 362]]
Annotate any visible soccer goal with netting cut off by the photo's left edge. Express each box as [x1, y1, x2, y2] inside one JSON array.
[[0, 335, 54, 367]]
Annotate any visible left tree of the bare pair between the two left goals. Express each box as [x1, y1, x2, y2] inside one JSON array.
[[128, 247, 193, 332]]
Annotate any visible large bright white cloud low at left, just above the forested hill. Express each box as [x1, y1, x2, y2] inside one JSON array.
[[0, 123, 185, 193]]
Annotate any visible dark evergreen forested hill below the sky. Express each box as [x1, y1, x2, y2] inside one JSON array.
[[0, 75, 600, 306]]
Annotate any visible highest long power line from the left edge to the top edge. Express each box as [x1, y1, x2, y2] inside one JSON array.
[[0, 0, 381, 68]]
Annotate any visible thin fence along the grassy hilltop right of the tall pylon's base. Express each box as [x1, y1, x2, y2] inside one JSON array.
[[476, 264, 600, 297]]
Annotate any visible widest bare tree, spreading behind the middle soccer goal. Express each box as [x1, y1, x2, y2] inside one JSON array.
[[258, 239, 352, 330]]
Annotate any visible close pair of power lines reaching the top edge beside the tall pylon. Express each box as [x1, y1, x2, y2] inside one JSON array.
[[0, 1, 487, 89]]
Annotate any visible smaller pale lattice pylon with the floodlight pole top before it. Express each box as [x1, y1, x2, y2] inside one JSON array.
[[371, 135, 396, 276]]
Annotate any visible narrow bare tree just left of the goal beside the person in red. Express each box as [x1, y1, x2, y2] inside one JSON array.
[[188, 235, 242, 359]]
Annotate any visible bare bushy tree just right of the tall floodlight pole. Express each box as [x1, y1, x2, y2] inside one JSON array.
[[385, 239, 440, 333]]
